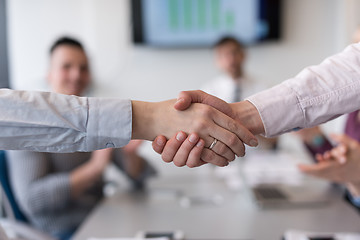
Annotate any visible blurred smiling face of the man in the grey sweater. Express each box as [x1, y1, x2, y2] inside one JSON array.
[[48, 45, 90, 96]]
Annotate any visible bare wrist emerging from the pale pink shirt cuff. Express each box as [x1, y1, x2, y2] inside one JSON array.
[[230, 101, 265, 135]]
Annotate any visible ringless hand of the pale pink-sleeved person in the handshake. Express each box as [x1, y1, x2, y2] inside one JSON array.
[[153, 91, 264, 166]]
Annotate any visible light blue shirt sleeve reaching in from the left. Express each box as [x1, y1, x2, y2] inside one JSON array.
[[0, 89, 132, 152]]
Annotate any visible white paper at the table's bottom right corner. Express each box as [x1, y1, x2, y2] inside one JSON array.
[[284, 230, 360, 240]]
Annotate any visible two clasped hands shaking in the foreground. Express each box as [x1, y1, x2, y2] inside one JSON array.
[[132, 90, 265, 167]]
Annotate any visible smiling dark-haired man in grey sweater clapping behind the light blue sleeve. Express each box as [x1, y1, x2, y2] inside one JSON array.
[[8, 38, 154, 239]]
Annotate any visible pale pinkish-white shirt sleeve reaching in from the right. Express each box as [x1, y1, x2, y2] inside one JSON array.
[[246, 43, 360, 137]]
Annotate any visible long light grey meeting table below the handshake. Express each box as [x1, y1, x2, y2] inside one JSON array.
[[74, 165, 360, 240]]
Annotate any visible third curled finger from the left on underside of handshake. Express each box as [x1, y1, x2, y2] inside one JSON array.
[[173, 133, 200, 167]]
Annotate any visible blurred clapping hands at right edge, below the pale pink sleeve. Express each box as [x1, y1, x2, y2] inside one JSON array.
[[299, 135, 360, 195]]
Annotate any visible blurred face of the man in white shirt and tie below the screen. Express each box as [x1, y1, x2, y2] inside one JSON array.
[[215, 42, 245, 79]]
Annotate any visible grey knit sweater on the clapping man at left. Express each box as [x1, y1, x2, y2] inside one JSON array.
[[8, 149, 153, 236]]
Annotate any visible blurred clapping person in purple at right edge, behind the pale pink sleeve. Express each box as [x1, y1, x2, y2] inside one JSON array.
[[290, 26, 360, 209]]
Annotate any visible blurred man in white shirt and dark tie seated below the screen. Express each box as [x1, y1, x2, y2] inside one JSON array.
[[201, 37, 277, 149]]
